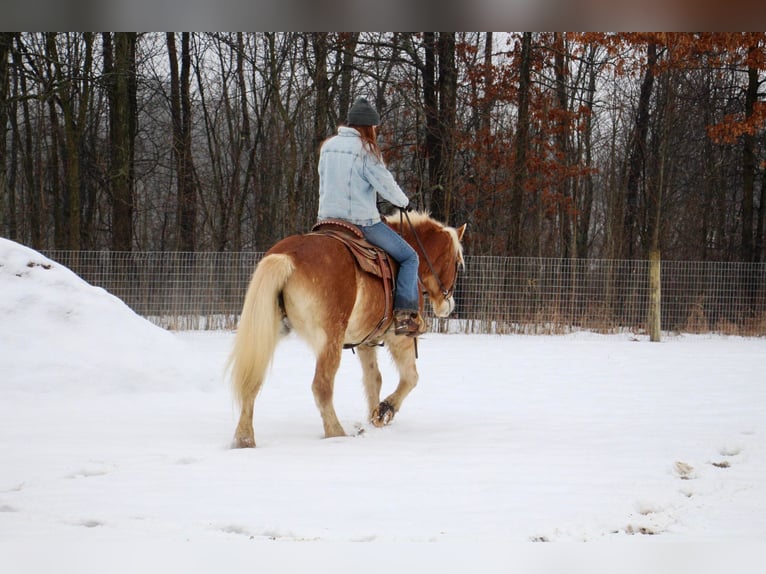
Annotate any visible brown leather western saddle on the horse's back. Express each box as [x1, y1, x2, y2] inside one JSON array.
[[311, 219, 396, 348]]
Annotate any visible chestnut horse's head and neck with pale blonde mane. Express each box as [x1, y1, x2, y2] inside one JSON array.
[[388, 213, 466, 317]]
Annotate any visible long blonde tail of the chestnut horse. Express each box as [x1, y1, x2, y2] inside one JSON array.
[[227, 254, 295, 405]]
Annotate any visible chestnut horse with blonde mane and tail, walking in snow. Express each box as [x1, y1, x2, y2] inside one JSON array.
[[227, 212, 466, 448]]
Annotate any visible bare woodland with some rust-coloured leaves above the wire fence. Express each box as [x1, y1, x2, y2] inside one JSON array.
[[0, 32, 766, 262]]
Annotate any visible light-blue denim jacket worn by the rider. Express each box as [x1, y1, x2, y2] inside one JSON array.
[[319, 126, 409, 226]]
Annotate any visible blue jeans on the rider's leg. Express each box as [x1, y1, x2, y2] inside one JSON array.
[[360, 221, 419, 312]]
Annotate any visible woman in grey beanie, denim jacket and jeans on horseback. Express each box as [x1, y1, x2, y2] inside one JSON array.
[[319, 98, 424, 337]]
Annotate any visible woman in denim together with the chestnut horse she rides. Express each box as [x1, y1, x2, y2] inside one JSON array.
[[228, 100, 466, 448]]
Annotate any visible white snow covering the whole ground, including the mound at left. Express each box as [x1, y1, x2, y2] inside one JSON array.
[[0, 239, 766, 572]]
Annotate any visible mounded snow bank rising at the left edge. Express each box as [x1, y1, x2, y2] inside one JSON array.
[[0, 238, 210, 393]]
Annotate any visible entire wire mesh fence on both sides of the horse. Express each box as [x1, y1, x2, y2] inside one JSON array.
[[45, 251, 766, 336]]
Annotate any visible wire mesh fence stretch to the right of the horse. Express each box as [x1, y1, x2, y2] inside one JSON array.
[[442, 257, 766, 335]]
